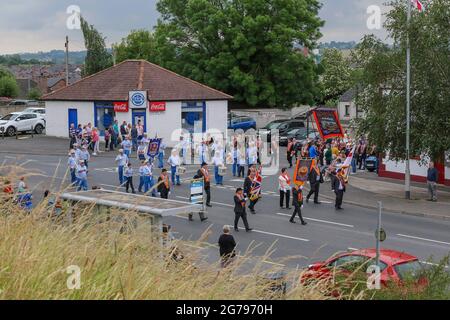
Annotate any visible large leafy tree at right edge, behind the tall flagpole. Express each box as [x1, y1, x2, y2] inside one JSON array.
[[353, 0, 450, 160]]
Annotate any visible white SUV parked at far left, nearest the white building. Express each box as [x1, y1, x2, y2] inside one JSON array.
[[0, 112, 45, 137]]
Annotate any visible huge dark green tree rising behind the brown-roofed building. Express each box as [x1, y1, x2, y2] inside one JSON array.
[[155, 0, 323, 107]]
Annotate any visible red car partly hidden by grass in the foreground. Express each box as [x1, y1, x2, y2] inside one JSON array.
[[301, 249, 426, 286]]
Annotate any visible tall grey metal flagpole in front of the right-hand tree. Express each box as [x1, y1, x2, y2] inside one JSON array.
[[405, 0, 411, 199]]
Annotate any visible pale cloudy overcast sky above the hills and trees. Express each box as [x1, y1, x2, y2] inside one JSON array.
[[0, 0, 387, 54]]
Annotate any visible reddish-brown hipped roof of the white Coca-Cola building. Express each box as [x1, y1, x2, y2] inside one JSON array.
[[41, 60, 233, 101]]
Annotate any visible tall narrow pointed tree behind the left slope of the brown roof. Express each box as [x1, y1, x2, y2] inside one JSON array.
[[80, 17, 112, 76]]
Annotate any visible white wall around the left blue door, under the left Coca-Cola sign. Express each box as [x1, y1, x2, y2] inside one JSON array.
[[45, 101, 94, 137]]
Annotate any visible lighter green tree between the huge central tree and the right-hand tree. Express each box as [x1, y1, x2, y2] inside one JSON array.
[[320, 49, 354, 106]]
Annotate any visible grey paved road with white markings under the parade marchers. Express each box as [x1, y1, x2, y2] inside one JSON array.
[[0, 153, 450, 267]]
